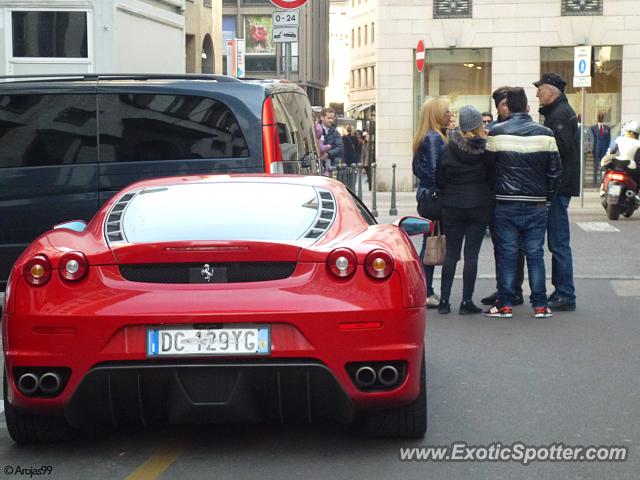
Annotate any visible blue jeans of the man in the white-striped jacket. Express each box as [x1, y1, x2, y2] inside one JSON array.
[[494, 202, 547, 308]]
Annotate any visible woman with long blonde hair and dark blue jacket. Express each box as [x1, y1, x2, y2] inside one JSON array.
[[412, 97, 451, 308]]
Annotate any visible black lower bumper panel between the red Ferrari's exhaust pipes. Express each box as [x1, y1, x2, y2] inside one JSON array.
[[64, 360, 355, 427]]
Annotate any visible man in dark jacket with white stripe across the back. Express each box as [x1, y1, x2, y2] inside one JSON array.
[[485, 87, 562, 318]]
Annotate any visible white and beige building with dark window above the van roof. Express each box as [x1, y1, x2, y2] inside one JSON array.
[[0, 0, 185, 75]]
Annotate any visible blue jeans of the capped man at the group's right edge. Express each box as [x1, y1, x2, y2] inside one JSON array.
[[547, 195, 576, 302]]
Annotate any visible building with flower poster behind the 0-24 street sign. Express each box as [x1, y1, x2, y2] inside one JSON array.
[[221, 0, 329, 105]]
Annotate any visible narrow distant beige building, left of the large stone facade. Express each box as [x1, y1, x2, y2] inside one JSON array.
[[347, 0, 378, 133]]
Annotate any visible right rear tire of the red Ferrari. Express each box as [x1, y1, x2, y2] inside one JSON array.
[[361, 354, 427, 438]]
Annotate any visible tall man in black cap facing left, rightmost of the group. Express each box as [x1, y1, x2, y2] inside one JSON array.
[[533, 73, 580, 311]]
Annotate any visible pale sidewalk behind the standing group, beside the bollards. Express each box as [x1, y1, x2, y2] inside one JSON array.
[[362, 188, 604, 223]]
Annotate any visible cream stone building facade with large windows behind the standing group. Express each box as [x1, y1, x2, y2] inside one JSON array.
[[376, 0, 640, 191]]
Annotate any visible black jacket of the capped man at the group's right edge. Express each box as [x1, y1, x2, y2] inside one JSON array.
[[538, 93, 580, 197]]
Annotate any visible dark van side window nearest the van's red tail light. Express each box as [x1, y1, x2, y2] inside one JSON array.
[[98, 94, 249, 162]]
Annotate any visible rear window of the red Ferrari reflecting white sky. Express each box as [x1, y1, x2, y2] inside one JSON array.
[[122, 182, 335, 243]]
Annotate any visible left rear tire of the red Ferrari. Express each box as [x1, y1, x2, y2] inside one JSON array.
[[2, 371, 75, 445]]
